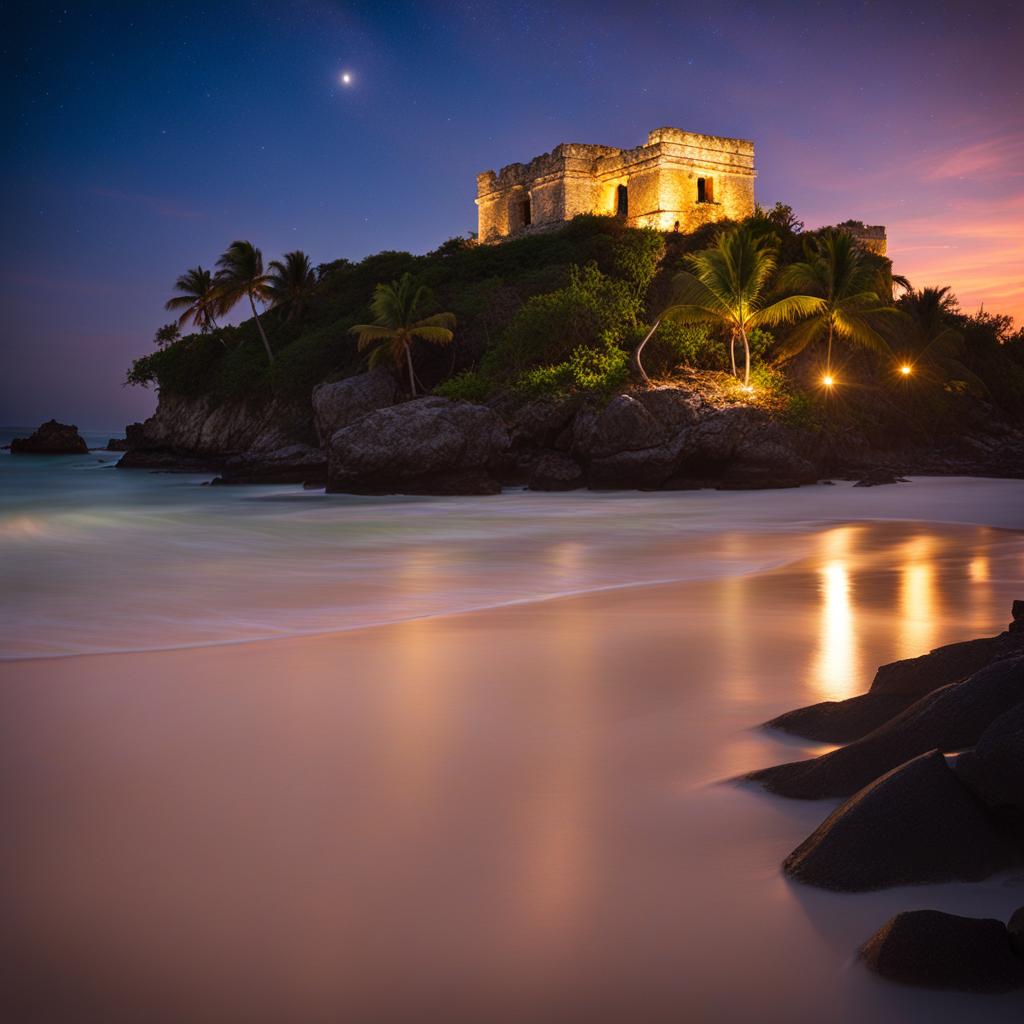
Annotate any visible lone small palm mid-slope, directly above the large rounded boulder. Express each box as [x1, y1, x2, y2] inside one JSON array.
[[349, 273, 455, 398]]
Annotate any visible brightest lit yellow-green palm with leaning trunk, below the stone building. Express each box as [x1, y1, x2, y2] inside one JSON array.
[[634, 227, 822, 387]]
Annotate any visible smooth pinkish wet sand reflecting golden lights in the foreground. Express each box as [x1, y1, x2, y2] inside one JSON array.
[[0, 522, 1024, 1024]]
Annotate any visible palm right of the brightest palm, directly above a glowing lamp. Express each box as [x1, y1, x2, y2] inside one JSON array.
[[779, 228, 900, 375]]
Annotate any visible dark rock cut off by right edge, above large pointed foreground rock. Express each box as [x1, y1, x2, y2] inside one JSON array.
[[953, 701, 1024, 826]]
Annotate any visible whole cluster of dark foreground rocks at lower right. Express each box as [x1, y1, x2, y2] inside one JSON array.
[[746, 601, 1024, 990]]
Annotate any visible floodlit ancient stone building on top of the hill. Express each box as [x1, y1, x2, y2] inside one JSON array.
[[476, 128, 757, 242]]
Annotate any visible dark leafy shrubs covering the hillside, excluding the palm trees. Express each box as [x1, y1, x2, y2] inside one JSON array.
[[128, 208, 1024, 437]]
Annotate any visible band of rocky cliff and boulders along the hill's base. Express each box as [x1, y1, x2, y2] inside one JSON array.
[[121, 371, 1024, 494]]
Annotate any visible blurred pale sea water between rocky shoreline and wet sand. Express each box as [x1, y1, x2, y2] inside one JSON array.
[[0, 430, 1024, 658]]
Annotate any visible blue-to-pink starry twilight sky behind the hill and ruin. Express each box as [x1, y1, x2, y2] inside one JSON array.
[[0, 0, 1024, 428]]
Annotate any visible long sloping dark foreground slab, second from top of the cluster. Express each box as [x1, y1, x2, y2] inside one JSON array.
[[746, 655, 1024, 800]]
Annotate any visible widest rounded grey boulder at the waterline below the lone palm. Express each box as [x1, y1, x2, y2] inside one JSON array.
[[328, 397, 509, 495]]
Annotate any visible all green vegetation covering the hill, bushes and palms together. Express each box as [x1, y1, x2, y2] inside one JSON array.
[[127, 206, 1024, 437]]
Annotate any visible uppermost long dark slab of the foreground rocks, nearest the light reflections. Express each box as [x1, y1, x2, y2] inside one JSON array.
[[766, 602, 1024, 743]]
